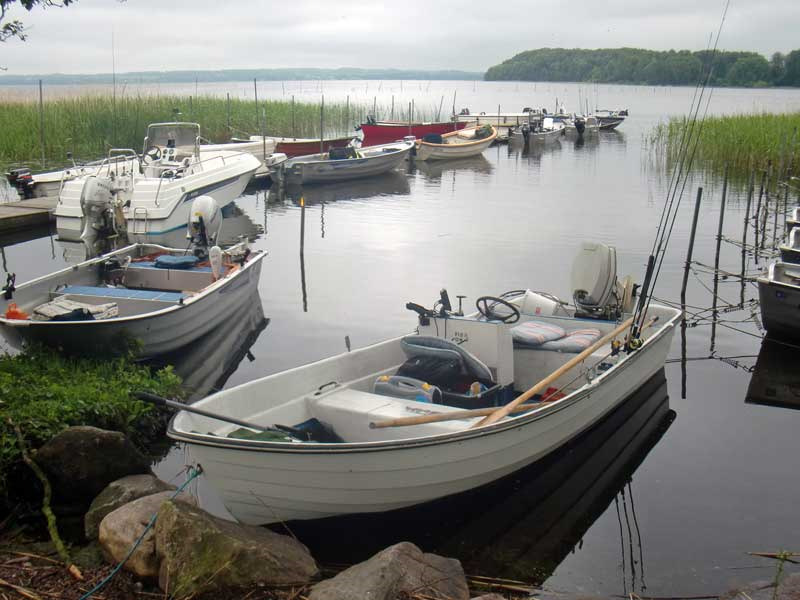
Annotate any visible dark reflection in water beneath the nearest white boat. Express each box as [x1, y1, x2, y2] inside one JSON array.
[[282, 369, 675, 585]]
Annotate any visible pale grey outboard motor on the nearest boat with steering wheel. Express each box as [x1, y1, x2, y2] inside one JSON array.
[[571, 242, 632, 320]]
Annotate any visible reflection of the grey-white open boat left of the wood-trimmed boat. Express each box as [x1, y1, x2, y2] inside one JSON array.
[[268, 171, 411, 206]]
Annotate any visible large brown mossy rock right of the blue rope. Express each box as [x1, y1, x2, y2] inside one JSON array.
[[156, 502, 318, 598]]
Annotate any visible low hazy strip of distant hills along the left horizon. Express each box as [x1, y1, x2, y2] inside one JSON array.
[[0, 68, 483, 85]]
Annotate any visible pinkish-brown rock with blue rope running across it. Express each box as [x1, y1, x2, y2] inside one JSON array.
[[99, 492, 196, 578]]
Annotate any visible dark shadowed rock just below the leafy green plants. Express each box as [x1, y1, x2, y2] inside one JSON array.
[[36, 427, 150, 506]]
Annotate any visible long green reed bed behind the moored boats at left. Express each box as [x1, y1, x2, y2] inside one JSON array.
[[0, 96, 430, 165]]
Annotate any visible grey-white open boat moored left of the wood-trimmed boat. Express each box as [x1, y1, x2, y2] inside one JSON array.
[[283, 140, 414, 184]]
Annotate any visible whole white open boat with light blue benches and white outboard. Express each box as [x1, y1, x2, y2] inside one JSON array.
[[0, 197, 266, 357]]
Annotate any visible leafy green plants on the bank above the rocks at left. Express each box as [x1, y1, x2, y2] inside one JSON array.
[[0, 349, 180, 506]]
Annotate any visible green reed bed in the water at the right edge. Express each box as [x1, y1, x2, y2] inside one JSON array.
[[649, 113, 800, 174]]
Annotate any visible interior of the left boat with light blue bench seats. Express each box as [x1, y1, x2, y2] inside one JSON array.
[[3, 244, 239, 322]]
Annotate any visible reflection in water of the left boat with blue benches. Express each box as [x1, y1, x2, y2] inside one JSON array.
[[149, 289, 269, 402]]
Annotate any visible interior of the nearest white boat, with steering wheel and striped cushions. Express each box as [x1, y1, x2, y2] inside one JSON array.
[[173, 244, 677, 443]]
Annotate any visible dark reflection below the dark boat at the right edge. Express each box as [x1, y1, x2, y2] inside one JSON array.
[[745, 337, 800, 409]]
